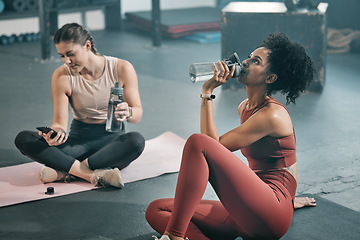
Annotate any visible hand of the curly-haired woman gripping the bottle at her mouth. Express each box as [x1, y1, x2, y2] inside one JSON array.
[[203, 61, 235, 94]]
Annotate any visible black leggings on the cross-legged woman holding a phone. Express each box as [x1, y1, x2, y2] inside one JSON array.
[[15, 120, 145, 172]]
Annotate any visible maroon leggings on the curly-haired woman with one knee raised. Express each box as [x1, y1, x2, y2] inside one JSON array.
[[146, 134, 296, 240]]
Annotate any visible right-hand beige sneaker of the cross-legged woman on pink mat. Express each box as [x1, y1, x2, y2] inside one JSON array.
[[90, 168, 124, 188]]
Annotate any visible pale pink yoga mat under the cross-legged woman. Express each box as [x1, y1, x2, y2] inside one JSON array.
[[0, 132, 185, 207]]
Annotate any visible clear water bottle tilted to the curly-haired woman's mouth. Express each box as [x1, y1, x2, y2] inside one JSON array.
[[189, 52, 242, 83]]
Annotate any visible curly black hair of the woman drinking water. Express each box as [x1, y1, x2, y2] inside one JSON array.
[[259, 33, 315, 104]]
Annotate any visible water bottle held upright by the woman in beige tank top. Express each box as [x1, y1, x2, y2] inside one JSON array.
[[105, 82, 125, 132]]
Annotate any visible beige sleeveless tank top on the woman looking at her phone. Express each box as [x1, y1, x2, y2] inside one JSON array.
[[65, 56, 118, 121]]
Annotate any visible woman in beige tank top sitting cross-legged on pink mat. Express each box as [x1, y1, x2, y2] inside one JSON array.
[[15, 23, 145, 188]]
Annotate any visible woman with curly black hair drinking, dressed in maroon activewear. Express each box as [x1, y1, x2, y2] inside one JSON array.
[[146, 33, 314, 240]]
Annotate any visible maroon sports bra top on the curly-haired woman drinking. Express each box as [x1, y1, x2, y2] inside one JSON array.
[[240, 99, 296, 170]]
